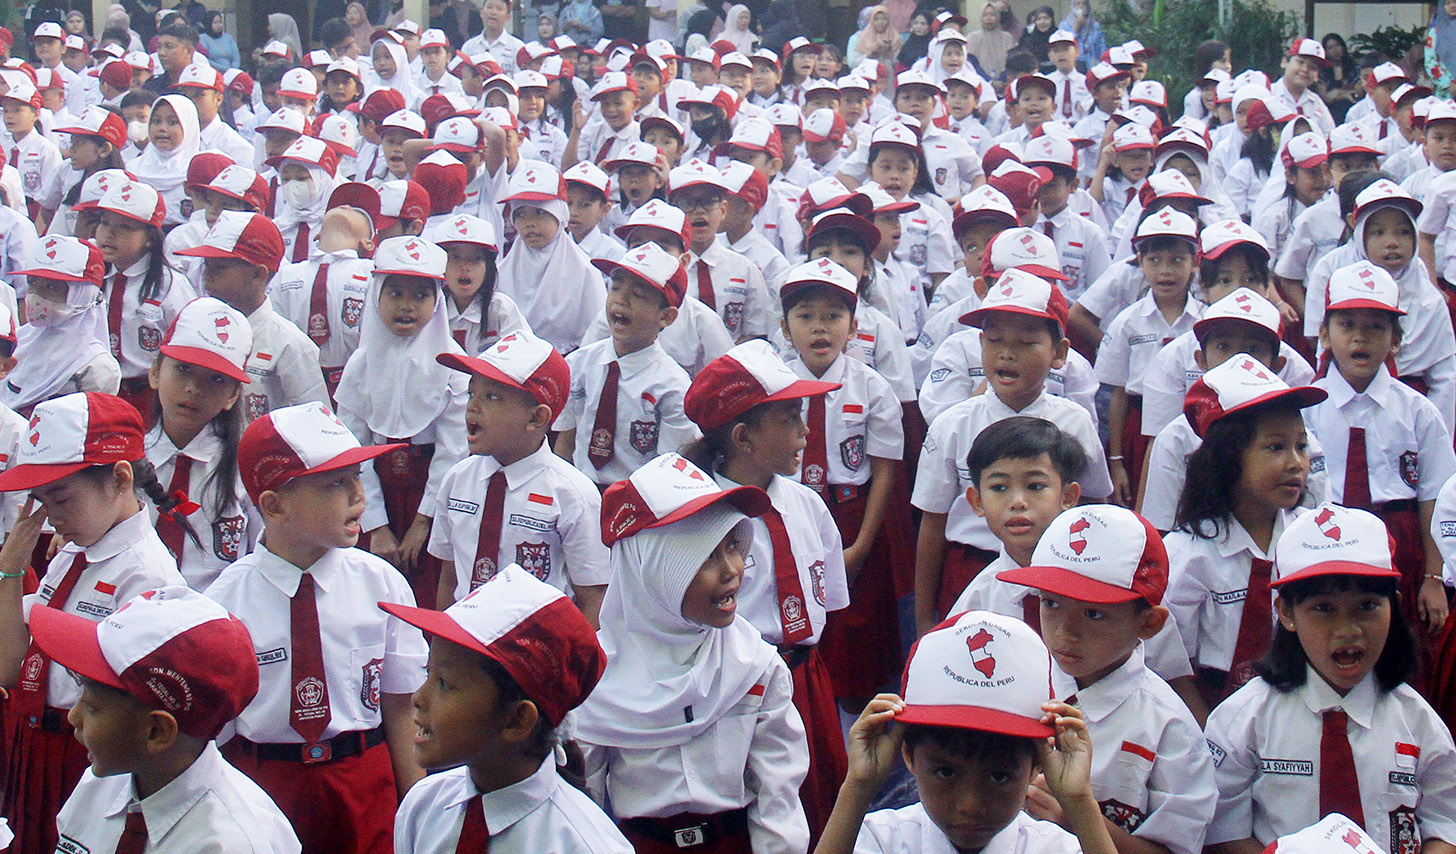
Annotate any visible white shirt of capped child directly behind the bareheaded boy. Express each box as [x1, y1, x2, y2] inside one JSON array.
[[910, 390, 1112, 551]]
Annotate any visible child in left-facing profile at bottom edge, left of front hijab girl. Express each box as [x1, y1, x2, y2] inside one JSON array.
[[381, 564, 632, 854]]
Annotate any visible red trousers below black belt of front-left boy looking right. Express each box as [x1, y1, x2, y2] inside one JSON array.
[[221, 739, 399, 854]]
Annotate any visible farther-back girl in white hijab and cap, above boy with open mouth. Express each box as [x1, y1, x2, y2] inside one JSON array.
[[498, 160, 607, 355]]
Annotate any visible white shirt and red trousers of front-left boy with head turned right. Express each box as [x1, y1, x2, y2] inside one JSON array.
[[207, 544, 428, 854]]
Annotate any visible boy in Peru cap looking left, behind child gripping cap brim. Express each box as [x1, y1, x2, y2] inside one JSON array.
[[997, 505, 1219, 854]]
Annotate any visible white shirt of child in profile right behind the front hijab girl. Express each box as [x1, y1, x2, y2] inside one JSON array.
[[715, 474, 849, 646]]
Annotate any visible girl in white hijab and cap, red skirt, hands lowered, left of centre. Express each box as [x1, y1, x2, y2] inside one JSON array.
[[335, 236, 463, 602]]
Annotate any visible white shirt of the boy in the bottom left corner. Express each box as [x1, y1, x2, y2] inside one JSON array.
[[55, 742, 300, 854]]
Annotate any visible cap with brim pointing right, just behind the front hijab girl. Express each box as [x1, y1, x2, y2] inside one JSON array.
[[683, 339, 839, 431]]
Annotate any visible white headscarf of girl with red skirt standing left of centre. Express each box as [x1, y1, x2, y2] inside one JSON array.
[[333, 266, 470, 438]]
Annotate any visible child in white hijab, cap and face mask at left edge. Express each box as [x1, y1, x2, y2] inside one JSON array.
[[0, 234, 121, 418]]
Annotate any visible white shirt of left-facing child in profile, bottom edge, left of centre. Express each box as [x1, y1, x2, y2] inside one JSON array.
[[395, 755, 632, 854]]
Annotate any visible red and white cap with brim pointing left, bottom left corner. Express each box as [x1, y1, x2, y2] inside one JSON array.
[[31, 585, 258, 739]]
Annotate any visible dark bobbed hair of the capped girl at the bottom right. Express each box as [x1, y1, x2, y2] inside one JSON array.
[[1254, 575, 1420, 691]]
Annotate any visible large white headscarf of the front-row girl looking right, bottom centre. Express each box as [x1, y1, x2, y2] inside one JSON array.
[[575, 503, 778, 749]]
